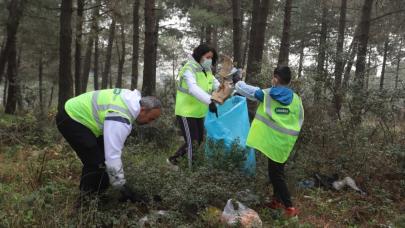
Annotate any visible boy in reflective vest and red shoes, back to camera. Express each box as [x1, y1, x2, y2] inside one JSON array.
[[235, 66, 304, 217]]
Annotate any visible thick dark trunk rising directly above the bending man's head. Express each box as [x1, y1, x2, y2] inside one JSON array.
[[142, 0, 157, 96]]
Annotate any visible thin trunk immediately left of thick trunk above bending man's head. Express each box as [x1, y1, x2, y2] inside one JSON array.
[[131, 0, 139, 90]]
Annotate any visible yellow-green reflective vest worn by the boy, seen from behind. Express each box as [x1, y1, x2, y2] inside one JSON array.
[[246, 89, 304, 163]]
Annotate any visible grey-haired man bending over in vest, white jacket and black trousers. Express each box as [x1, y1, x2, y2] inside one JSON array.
[[56, 88, 161, 201]]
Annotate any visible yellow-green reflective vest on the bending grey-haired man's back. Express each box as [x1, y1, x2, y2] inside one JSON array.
[[65, 88, 135, 137]]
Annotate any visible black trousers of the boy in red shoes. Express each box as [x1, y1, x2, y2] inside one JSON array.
[[268, 158, 292, 207]]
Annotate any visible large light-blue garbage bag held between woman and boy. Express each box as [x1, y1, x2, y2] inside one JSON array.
[[204, 96, 256, 175]]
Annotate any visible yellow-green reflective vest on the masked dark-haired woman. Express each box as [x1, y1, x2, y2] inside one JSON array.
[[175, 59, 214, 118]]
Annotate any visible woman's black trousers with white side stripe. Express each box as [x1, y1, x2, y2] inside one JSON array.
[[170, 116, 204, 160]]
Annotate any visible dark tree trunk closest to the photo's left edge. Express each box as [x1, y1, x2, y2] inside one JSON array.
[[5, 0, 24, 114]]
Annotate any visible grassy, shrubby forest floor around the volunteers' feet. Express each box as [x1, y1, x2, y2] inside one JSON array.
[[0, 115, 405, 227]]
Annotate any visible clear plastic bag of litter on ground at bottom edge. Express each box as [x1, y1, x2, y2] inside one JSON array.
[[221, 199, 263, 228]]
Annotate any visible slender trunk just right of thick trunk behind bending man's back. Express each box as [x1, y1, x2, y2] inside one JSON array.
[[75, 0, 84, 96]]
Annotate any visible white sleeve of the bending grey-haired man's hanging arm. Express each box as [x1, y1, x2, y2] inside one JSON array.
[[103, 116, 132, 187]]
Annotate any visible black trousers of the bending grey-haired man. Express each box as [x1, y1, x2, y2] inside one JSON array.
[[56, 110, 109, 193]]
